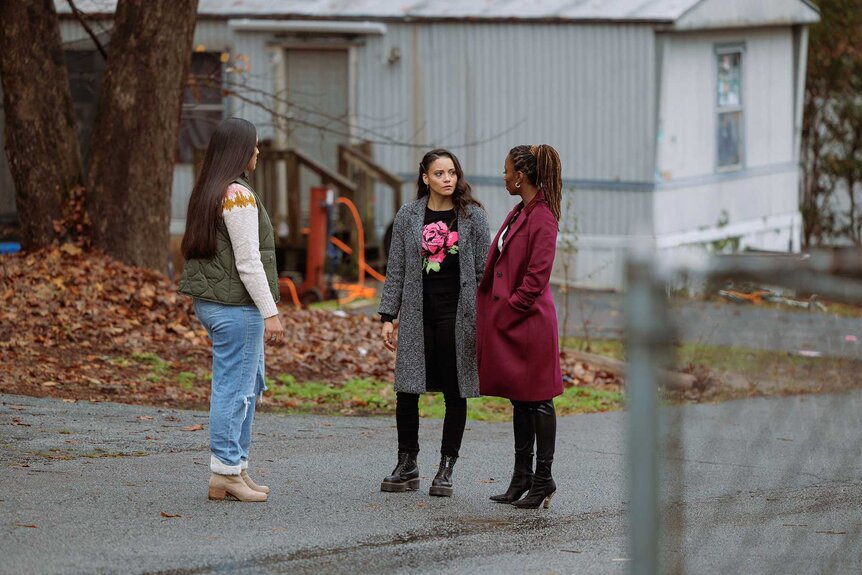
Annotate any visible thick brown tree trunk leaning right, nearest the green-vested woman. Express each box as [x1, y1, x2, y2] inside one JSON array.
[[86, 0, 198, 271]]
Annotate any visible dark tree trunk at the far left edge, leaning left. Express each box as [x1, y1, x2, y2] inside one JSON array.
[[0, 0, 82, 250]]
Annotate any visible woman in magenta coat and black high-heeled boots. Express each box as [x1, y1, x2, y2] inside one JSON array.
[[476, 145, 563, 509]]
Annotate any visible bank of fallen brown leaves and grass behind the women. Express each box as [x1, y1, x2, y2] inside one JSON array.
[[0, 248, 621, 413]]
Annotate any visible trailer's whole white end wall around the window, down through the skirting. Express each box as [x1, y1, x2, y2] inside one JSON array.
[[653, 28, 799, 254]]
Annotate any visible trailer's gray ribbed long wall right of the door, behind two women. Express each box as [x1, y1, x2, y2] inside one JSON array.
[[357, 23, 655, 238]]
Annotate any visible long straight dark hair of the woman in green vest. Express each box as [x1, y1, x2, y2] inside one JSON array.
[[180, 118, 257, 260]]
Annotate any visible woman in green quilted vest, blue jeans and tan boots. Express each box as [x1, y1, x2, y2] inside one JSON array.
[[180, 118, 284, 501]]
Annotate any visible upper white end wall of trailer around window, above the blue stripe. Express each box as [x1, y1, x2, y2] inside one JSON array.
[[658, 28, 794, 181]]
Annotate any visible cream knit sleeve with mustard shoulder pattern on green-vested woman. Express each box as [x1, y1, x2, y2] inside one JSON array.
[[222, 184, 278, 318]]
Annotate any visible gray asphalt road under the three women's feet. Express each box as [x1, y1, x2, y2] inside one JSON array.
[[0, 392, 862, 575]]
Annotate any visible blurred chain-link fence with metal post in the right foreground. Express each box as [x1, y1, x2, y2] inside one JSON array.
[[625, 253, 862, 574]]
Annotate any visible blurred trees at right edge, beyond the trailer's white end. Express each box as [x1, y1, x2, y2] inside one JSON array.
[[800, 0, 862, 246]]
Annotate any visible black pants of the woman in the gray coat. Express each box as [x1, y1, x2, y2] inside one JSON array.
[[395, 292, 467, 457]]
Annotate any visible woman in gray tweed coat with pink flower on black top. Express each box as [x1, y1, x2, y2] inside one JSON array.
[[378, 149, 490, 497]]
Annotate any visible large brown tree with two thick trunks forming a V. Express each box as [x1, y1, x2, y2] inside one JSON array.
[[0, 0, 198, 271]]
